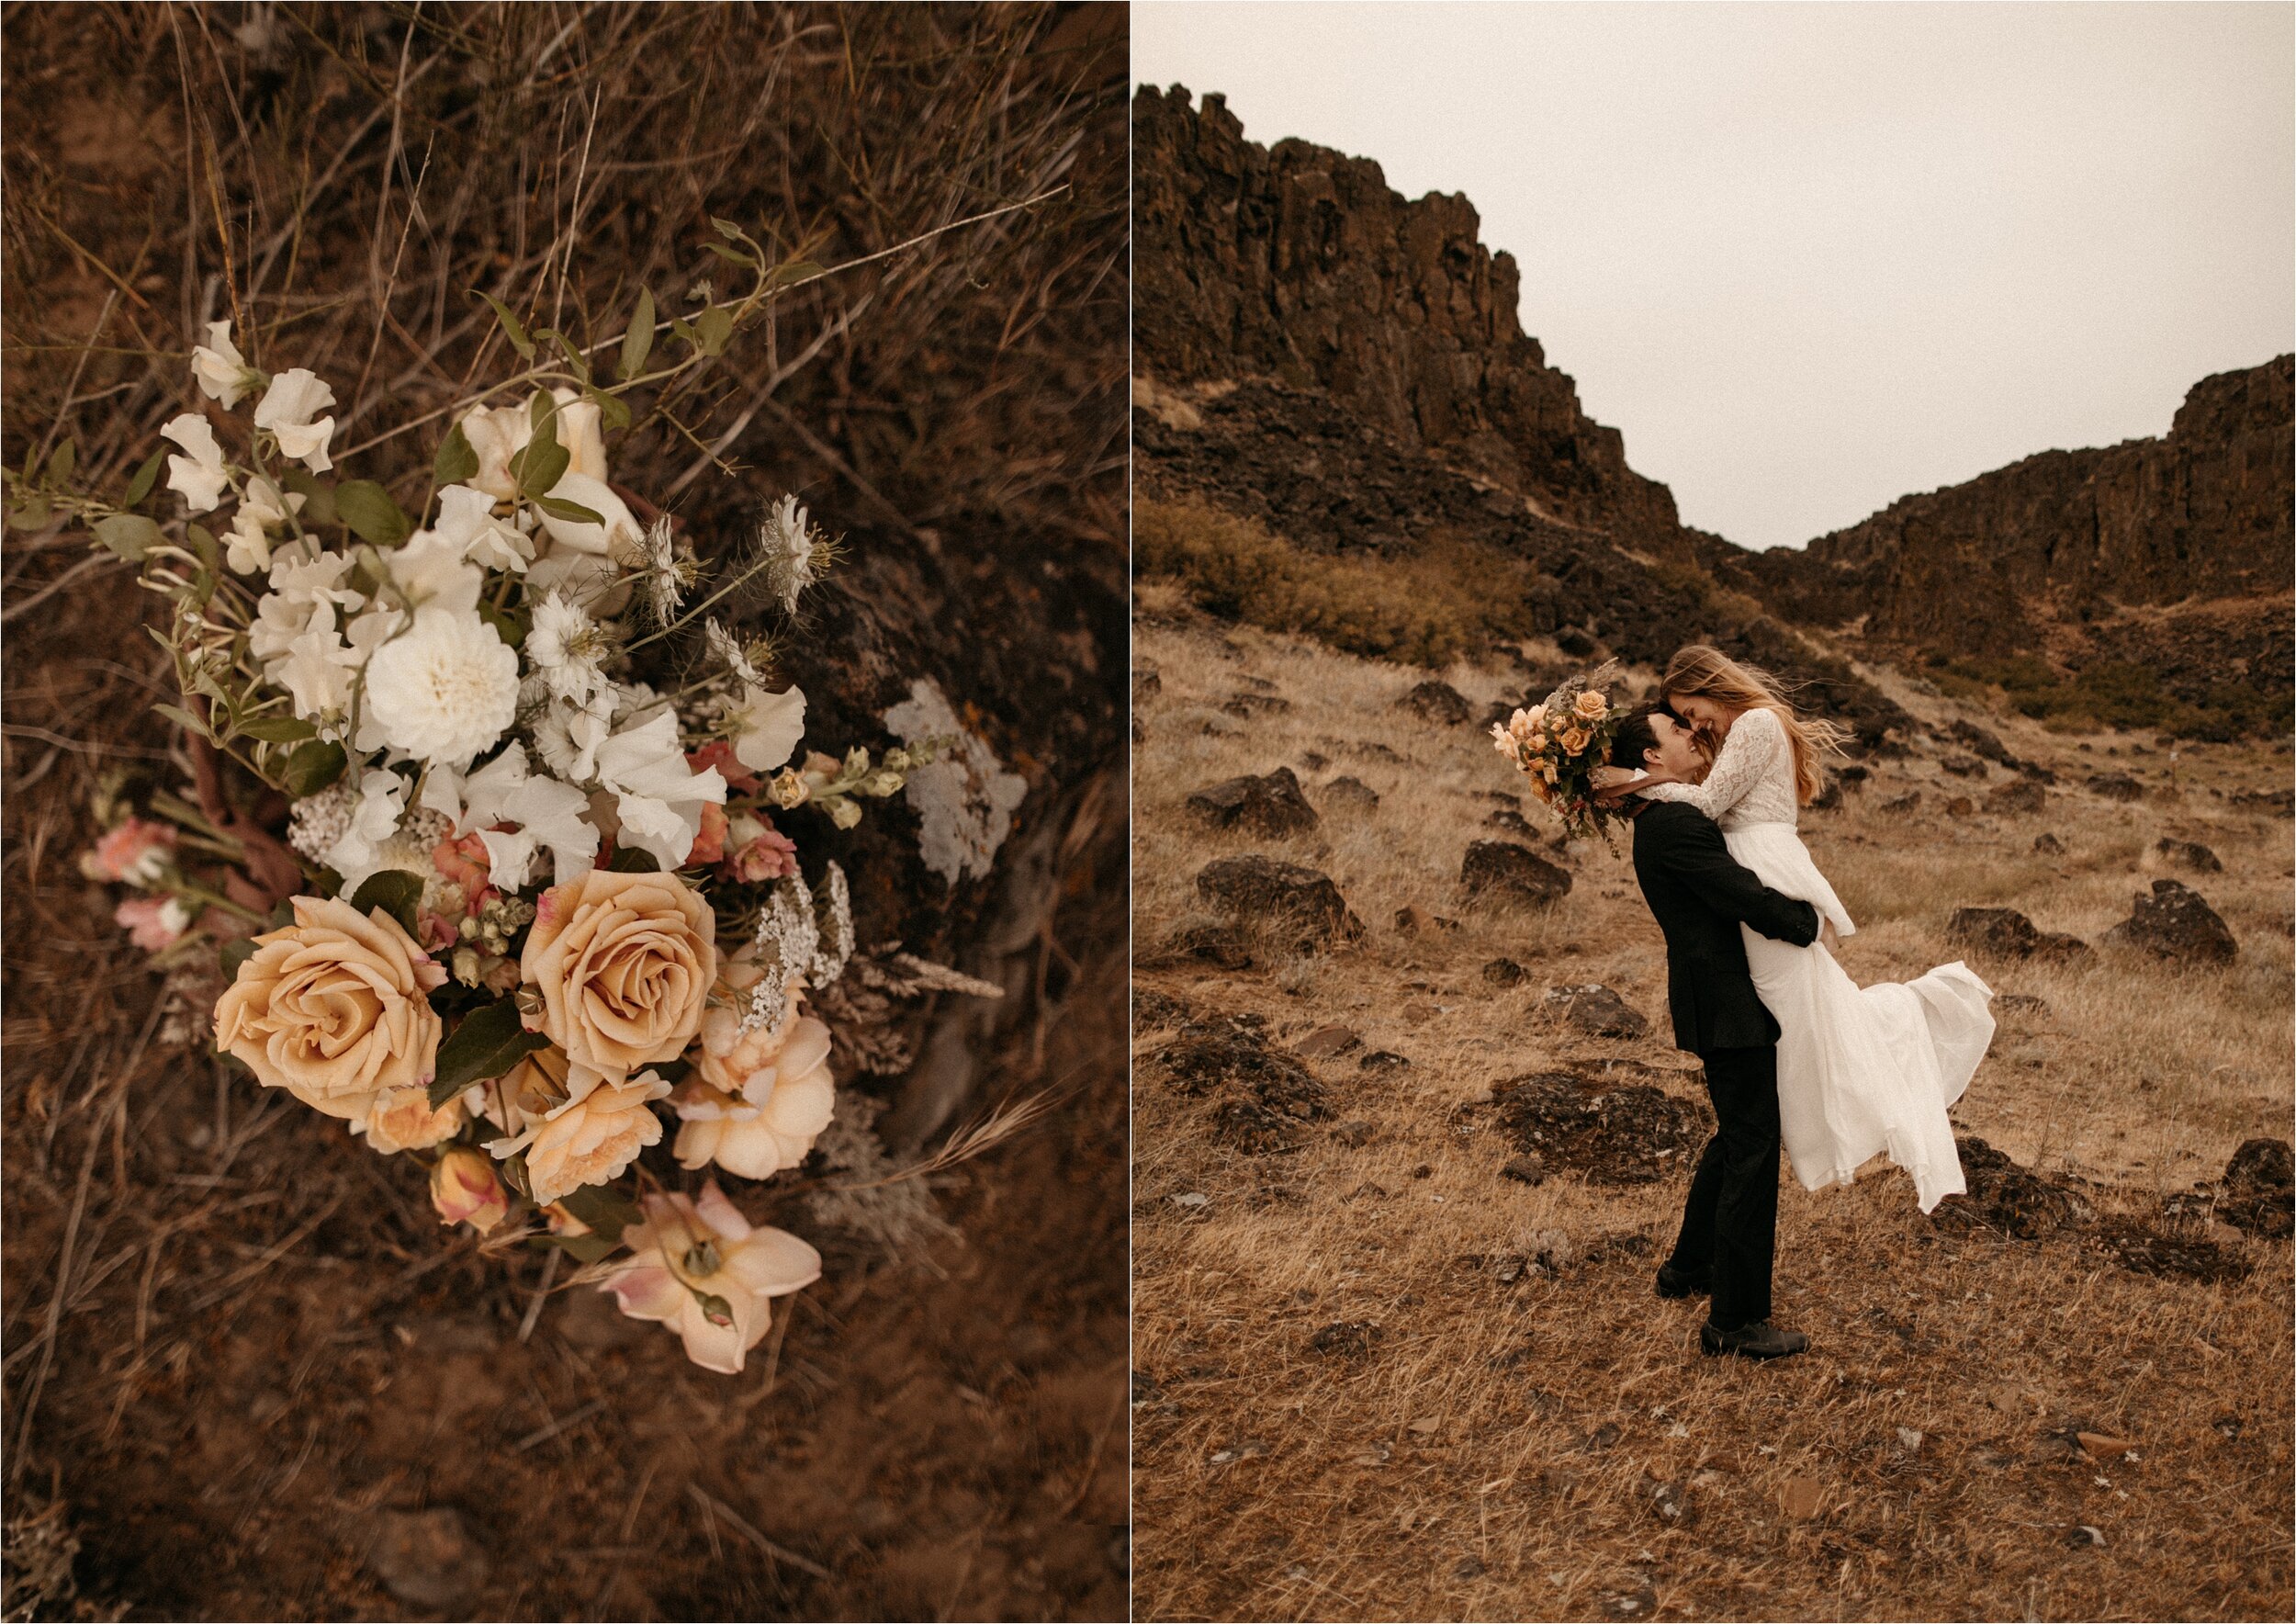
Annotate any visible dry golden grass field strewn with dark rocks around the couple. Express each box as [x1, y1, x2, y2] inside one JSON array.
[[1132, 581, 2296, 1619]]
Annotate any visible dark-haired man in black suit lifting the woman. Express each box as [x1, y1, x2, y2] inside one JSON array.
[[1610, 705, 1818, 1359]]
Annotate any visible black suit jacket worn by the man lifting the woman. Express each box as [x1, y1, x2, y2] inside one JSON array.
[[1635, 802, 1818, 1054]]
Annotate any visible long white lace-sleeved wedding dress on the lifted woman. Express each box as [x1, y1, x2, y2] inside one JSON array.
[[1639, 710, 1993, 1212]]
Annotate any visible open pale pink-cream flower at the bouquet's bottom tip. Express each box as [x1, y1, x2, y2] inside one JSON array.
[[602, 1183, 822, 1376]]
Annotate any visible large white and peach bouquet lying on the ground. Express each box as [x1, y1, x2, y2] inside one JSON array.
[[33, 250, 995, 1371]]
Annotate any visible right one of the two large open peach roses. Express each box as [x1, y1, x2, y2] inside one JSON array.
[[519, 868, 716, 1077]]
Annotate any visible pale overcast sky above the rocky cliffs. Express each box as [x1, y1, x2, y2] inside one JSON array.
[[1132, 0, 2296, 547]]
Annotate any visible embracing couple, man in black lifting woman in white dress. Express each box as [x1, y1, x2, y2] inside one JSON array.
[[1593, 646, 1993, 1358]]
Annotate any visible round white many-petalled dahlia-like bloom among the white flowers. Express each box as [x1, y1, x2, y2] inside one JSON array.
[[361, 611, 519, 765]]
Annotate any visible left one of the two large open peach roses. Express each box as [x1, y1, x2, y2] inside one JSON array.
[[216, 896, 445, 1121]]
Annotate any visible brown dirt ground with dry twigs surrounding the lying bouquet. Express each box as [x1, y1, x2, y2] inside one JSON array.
[[0, 5, 1128, 1619]]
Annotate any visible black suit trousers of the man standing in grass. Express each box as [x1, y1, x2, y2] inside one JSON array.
[[1671, 1043, 1780, 1330]]
